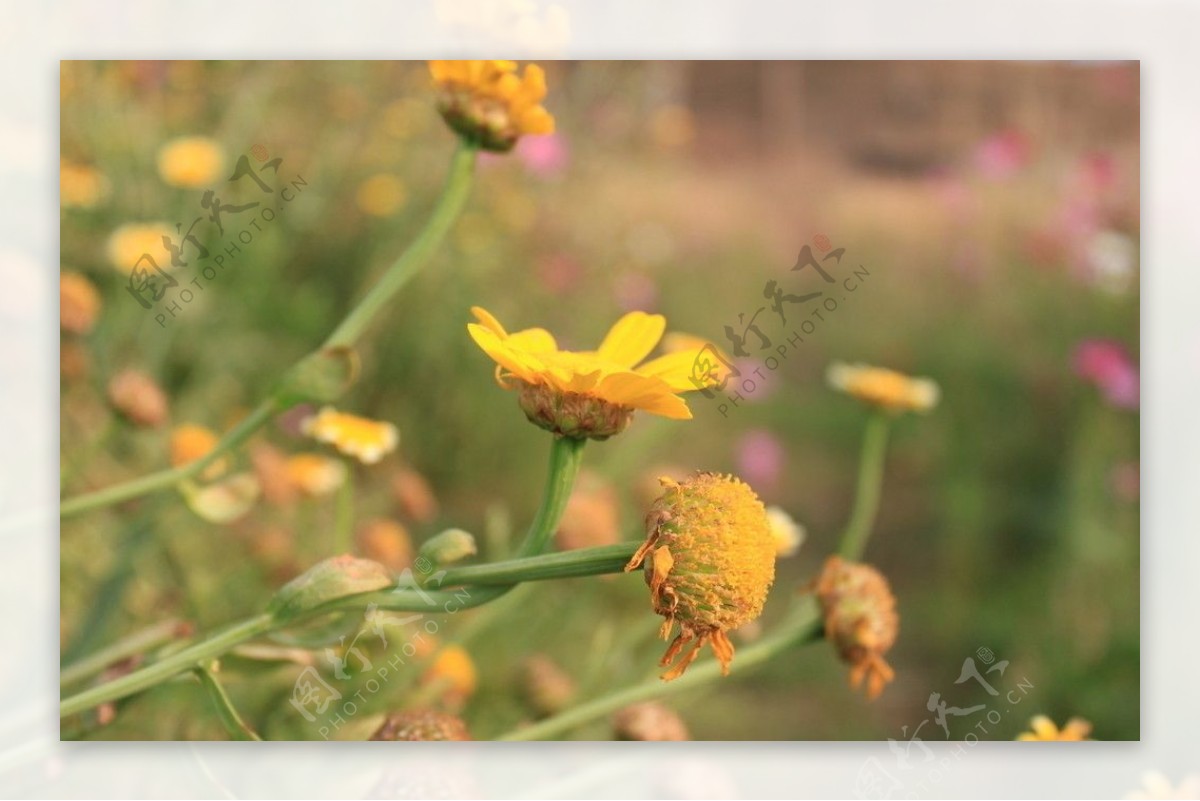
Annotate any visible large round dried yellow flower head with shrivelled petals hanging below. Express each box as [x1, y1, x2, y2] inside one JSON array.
[[625, 472, 775, 681]]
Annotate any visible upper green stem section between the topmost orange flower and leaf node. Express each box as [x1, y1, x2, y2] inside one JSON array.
[[324, 141, 475, 348]]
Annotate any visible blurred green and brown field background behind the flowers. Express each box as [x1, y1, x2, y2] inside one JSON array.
[[61, 62, 1140, 740]]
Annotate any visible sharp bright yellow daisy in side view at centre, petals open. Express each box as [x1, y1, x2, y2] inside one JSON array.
[[467, 306, 698, 439]]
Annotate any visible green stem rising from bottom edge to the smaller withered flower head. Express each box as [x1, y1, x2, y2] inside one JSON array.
[[497, 598, 821, 740]]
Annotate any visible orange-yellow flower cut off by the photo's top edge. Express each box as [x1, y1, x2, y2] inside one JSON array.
[[430, 61, 554, 152]]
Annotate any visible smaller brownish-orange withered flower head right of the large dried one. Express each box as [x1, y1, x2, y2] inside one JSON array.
[[816, 556, 900, 699]]
